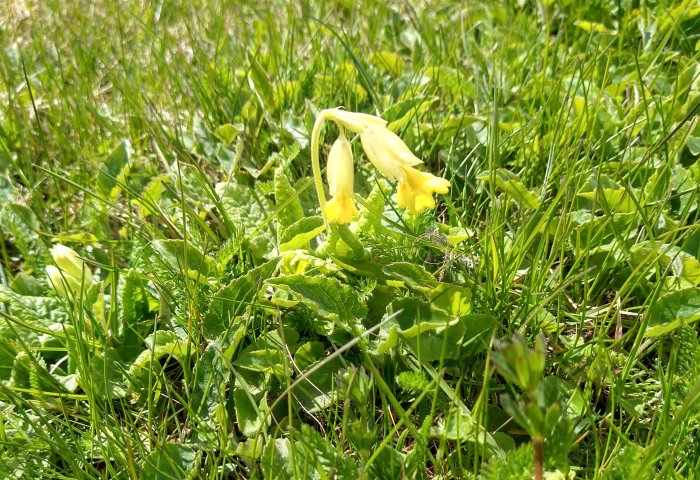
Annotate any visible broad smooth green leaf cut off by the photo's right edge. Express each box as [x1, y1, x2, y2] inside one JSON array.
[[644, 287, 700, 338]]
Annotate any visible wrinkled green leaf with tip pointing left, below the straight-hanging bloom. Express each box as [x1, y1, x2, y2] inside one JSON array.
[[266, 275, 367, 335]]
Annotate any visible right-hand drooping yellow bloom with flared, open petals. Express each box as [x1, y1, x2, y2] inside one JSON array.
[[360, 125, 450, 213]]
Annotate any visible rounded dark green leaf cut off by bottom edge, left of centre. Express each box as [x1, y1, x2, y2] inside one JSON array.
[[140, 443, 197, 480]]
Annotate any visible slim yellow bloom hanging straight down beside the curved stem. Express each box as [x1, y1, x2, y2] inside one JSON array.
[[324, 131, 359, 223]]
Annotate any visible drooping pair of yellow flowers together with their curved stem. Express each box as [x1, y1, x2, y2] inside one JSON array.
[[311, 108, 450, 223]]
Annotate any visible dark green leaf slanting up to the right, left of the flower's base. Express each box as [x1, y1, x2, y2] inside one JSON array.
[[202, 260, 279, 342]]
